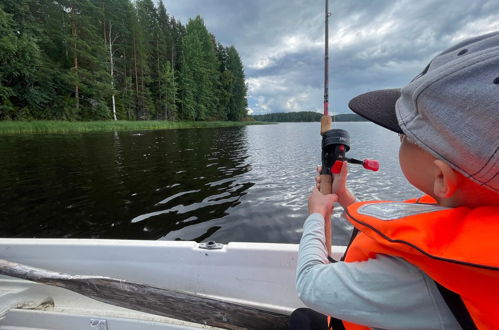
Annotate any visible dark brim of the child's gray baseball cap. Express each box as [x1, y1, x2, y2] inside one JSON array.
[[348, 88, 404, 133]]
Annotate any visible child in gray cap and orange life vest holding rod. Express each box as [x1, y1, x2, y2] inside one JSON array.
[[291, 32, 499, 329]]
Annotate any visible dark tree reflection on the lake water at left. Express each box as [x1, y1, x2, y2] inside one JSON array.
[[0, 128, 254, 239]]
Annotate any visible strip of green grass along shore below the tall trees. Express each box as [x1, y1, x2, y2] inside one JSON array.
[[0, 120, 268, 135]]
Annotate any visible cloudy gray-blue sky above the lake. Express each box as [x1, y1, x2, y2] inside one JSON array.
[[164, 0, 499, 114]]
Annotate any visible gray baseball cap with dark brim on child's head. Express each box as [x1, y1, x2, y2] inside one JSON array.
[[348, 32, 499, 192]]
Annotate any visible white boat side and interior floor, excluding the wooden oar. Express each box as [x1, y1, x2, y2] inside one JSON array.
[[0, 238, 345, 330]]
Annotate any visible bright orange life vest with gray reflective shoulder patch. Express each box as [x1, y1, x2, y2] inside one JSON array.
[[332, 196, 499, 329]]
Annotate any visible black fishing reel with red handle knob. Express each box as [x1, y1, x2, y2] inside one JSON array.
[[321, 129, 379, 175]]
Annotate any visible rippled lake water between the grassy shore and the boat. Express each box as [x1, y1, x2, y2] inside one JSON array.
[[0, 123, 419, 244]]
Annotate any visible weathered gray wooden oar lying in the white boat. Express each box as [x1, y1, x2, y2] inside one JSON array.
[[0, 259, 289, 329]]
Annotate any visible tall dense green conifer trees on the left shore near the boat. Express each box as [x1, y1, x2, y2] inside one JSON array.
[[0, 0, 247, 121]]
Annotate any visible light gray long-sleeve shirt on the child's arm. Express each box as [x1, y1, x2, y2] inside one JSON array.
[[296, 213, 460, 329]]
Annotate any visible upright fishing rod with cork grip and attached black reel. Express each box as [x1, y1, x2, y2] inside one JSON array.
[[320, 0, 379, 258]]
